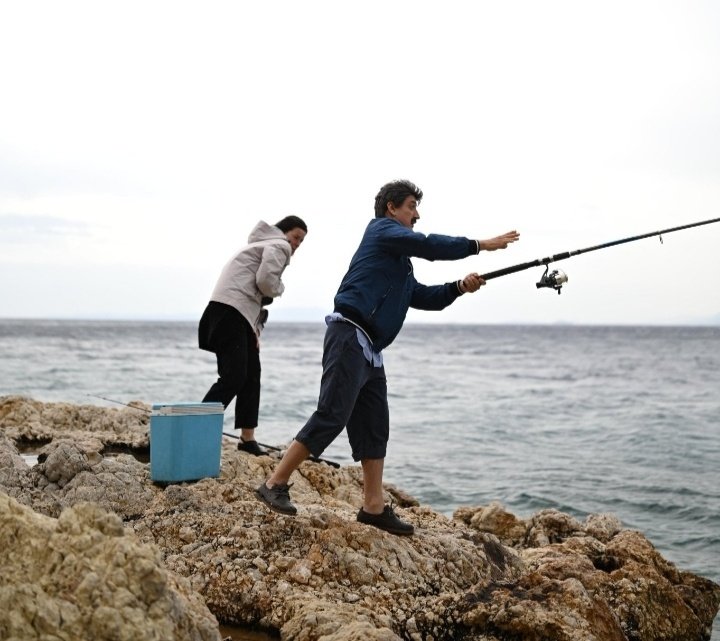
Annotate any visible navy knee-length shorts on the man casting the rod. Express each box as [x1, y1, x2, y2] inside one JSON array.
[[295, 321, 390, 461]]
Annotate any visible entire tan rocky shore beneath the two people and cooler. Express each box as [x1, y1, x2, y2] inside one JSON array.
[[0, 397, 720, 641]]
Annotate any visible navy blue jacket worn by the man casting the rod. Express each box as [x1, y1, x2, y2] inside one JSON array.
[[335, 218, 478, 351]]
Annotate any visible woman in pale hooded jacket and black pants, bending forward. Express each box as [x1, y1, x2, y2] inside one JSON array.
[[198, 216, 307, 456]]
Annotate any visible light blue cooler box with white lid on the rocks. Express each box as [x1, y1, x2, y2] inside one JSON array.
[[150, 403, 224, 483]]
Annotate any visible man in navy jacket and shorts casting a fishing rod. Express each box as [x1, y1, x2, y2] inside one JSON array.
[[256, 180, 520, 536]]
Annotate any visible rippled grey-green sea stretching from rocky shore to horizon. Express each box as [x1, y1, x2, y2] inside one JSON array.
[[0, 319, 720, 641]]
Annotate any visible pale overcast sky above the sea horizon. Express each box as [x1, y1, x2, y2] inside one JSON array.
[[0, 0, 720, 324]]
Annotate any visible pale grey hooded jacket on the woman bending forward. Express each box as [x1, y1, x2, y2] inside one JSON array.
[[210, 220, 292, 336]]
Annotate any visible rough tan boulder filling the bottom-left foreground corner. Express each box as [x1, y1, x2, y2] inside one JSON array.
[[0, 494, 220, 641]]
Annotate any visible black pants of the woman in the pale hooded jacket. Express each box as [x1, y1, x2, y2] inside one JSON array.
[[200, 303, 260, 429]]
